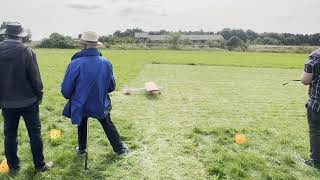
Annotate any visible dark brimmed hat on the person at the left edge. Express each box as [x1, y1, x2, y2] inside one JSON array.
[[0, 22, 29, 37]]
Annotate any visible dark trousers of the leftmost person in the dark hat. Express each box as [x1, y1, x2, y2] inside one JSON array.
[[2, 104, 45, 169]]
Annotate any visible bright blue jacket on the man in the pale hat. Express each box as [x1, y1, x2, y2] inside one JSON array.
[[61, 48, 116, 124]]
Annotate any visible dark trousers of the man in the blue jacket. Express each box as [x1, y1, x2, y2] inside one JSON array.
[[78, 114, 124, 152]]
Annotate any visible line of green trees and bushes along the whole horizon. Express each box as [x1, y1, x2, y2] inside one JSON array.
[[0, 22, 320, 49]]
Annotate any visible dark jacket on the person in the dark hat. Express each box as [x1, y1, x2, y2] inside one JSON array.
[[0, 40, 43, 108]]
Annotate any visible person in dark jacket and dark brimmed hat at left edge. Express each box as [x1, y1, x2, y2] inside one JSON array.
[[0, 22, 52, 172]]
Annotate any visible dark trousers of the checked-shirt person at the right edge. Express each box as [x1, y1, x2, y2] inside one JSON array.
[[307, 108, 320, 162]]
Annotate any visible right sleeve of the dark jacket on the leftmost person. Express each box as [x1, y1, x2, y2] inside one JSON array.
[[26, 48, 43, 103]]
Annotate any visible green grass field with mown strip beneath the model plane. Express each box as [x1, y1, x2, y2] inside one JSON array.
[[0, 50, 320, 179]]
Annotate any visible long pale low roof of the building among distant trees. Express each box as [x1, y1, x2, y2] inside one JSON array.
[[135, 32, 224, 41]]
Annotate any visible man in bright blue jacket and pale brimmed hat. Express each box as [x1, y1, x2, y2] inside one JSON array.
[[61, 32, 128, 155]]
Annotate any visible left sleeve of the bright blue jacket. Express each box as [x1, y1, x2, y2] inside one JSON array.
[[61, 63, 79, 99]]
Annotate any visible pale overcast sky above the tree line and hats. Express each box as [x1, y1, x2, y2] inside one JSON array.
[[0, 0, 320, 40]]
